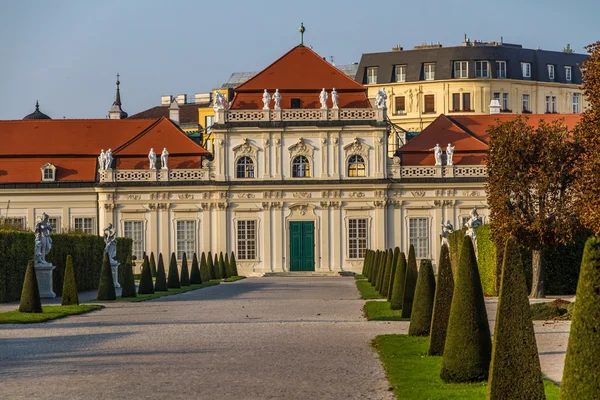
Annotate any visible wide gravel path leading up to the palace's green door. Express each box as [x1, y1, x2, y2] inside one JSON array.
[[0, 277, 408, 400]]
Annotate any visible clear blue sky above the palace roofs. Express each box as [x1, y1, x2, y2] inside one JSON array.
[[0, 0, 600, 119]]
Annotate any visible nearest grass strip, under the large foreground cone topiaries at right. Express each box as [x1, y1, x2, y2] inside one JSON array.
[[373, 335, 559, 400]]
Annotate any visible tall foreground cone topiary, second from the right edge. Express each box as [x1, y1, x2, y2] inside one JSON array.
[[487, 238, 548, 400]]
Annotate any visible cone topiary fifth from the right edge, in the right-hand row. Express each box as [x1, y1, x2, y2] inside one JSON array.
[[408, 260, 435, 336]]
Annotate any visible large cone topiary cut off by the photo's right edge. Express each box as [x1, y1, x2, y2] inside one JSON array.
[[560, 237, 600, 400]]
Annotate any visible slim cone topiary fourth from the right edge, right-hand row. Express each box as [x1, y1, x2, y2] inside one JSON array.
[[428, 244, 454, 356]]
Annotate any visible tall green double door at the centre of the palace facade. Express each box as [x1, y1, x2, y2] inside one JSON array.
[[290, 221, 315, 271]]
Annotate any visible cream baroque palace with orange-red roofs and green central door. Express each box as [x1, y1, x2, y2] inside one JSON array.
[[0, 45, 577, 276]]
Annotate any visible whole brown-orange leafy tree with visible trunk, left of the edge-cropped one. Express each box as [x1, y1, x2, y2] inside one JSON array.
[[487, 117, 579, 298]]
